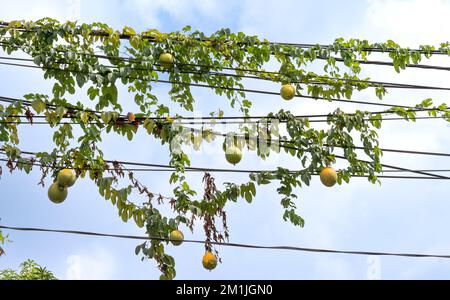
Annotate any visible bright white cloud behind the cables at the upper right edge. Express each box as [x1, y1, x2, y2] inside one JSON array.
[[356, 0, 450, 168]]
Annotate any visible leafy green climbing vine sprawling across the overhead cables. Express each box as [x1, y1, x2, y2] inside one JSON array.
[[0, 18, 450, 279]]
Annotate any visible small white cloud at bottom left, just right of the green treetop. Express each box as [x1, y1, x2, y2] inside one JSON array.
[[66, 248, 116, 280]]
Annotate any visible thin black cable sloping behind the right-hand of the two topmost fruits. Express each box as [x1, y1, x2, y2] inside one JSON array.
[[0, 62, 415, 109]]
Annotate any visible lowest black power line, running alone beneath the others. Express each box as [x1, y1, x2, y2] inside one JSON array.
[[0, 226, 450, 259]]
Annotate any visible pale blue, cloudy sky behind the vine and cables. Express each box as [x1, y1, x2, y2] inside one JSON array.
[[0, 0, 450, 280]]
